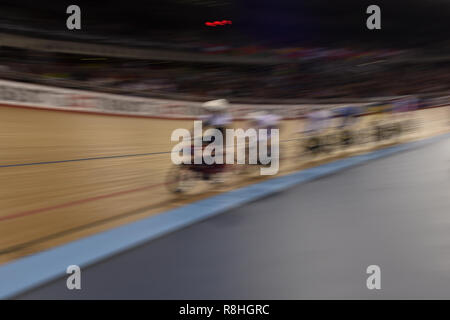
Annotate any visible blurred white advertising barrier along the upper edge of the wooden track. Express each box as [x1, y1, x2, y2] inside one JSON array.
[[0, 80, 412, 119]]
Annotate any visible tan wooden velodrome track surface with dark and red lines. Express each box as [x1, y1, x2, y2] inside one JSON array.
[[0, 107, 449, 263]]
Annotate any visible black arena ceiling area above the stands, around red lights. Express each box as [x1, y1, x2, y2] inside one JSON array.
[[0, 0, 450, 46]]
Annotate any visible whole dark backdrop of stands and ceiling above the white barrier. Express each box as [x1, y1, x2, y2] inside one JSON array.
[[0, 0, 450, 102]]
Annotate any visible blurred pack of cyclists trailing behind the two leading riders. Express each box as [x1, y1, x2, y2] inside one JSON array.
[[298, 97, 419, 154]]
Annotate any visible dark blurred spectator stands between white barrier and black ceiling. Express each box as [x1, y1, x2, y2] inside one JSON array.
[[0, 47, 450, 101]]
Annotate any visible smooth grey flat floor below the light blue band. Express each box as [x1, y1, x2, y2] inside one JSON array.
[[18, 138, 450, 299]]
